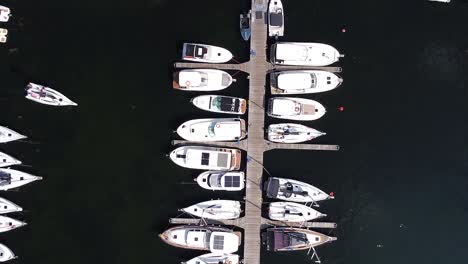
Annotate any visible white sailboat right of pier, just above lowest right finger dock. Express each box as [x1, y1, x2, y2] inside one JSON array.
[[268, 202, 327, 223]]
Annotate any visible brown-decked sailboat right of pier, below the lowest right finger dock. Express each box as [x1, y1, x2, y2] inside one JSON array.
[[262, 227, 336, 251]]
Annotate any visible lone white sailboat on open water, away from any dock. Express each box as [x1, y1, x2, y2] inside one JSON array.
[[26, 83, 78, 106]]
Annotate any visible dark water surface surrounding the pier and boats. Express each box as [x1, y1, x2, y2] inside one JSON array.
[[0, 0, 468, 264]]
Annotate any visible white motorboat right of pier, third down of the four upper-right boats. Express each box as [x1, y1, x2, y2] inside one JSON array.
[[267, 97, 326, 121]]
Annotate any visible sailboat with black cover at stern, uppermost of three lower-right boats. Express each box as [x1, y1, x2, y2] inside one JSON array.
[[263, 177, 334, 203]]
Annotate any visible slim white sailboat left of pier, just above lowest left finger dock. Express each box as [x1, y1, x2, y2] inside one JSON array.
[[180, 200, 242, 220]]
